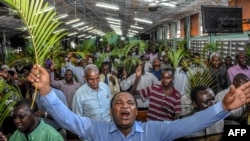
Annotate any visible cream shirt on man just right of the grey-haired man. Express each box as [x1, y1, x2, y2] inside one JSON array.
[[100, 73, 120, 96]]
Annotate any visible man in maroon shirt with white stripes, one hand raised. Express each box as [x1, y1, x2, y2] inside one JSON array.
[[130, 68, 181, 121]]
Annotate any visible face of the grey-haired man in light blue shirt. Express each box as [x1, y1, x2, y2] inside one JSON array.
[[85, 71, 100, 90]]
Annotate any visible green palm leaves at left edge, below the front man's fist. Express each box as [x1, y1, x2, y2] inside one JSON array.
[[0, 79, 23, 125]]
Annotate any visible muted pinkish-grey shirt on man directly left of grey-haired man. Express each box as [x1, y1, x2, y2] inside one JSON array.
[[50, 72, 81, 109]]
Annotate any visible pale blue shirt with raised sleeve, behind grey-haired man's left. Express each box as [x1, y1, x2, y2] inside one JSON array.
[[66, 62, 85, 85]]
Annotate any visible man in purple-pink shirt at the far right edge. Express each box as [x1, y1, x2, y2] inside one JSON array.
[[228, 51, 250, 84]]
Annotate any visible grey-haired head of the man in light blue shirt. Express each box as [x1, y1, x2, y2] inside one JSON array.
[[84, 64, 100, 90]]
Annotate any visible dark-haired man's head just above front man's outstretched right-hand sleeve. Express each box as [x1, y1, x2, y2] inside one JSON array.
[[191, 85, 215, 111]]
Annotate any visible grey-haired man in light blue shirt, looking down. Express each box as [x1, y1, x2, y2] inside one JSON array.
[[72, 64, 112, 122]]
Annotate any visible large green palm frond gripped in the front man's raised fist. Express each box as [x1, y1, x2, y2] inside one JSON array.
[[2, 0, 66, 107]]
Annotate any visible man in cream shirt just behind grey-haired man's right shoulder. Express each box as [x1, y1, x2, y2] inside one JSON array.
[[100, 62, 120, 96]]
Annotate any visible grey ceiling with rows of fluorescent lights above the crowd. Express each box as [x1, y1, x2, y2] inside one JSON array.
[[0, 0, 228, 37]]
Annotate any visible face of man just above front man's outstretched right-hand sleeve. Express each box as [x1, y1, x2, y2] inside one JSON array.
[[193, 89, 215, 111]]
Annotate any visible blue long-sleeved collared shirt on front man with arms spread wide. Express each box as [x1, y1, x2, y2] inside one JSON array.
[[41, 90, 229, 141]]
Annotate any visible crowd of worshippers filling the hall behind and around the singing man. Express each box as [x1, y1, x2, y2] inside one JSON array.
[[0, 45, 250, 141]]
